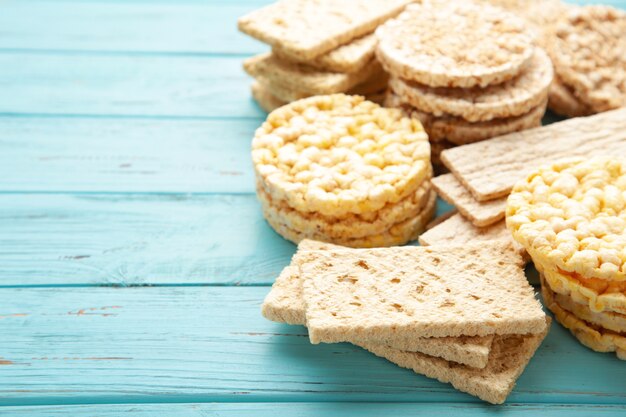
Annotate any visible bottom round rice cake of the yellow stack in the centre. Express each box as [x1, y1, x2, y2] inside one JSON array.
[[263, 191, 437, 248]]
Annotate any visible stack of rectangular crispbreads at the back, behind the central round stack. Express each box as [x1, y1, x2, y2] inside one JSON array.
[[238, 0, 410, 112]]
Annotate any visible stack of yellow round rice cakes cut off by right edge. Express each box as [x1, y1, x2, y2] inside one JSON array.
[[506, 157, 626, 360]]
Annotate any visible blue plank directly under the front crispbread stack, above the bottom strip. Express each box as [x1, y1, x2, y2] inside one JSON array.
[[0, 287, 626, 404]]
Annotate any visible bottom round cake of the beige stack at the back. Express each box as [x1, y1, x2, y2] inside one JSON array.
[[385, 91, 546, 145]]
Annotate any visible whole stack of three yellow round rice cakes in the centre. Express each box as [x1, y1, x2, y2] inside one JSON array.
[[252, 94, 436, 247]]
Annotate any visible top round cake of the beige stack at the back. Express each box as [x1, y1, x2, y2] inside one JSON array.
[[376, 1, 535, 88]]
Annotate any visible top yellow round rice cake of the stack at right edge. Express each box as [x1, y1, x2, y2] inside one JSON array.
[[506, 158, 626, 281]]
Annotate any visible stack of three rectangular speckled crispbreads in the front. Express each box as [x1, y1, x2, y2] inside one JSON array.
[[262, 240, 549, 403]]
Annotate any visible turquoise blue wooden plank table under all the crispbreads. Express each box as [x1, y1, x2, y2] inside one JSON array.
[[0, 0, 626, 417]]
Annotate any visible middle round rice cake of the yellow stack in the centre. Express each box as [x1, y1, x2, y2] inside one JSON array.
[[257, 176, 431, 239]]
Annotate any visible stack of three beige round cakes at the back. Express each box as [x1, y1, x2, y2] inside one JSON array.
[[376, 0, 553, 169]]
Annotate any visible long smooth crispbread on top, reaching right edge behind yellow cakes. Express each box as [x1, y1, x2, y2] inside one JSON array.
[[441, 108, 626, 201]]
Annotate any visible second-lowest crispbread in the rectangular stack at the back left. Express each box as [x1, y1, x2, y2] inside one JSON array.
[[243, 53, 384, 95]]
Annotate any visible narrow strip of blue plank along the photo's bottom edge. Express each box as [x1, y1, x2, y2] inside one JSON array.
[[2, 403, 626, 417]]
